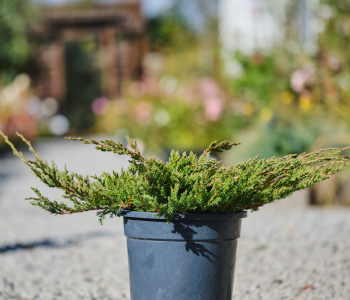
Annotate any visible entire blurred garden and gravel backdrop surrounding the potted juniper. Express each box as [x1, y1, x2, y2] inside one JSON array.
[[0, 0, 350, 300]]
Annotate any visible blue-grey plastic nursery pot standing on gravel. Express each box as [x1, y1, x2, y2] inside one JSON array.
[[122, 211, 247, 300]]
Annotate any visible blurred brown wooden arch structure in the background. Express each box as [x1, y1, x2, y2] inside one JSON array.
[[30, 0, 146, 101]]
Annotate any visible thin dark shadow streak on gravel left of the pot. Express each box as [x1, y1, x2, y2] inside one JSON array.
[[0, 231, 116, 255]]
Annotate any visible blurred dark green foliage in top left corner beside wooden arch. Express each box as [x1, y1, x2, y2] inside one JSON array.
[[0, 0, 36, 84]]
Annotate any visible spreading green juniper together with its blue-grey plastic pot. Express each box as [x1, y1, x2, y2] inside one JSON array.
[[1, 133, 350, 300]]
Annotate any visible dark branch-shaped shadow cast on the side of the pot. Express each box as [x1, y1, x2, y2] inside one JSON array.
[[172, 221, 217, 263]]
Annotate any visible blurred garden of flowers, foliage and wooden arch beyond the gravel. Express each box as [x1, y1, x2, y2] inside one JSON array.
[[0, 0, 350, 205]]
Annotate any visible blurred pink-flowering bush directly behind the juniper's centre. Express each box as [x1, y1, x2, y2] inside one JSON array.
[[97, 75, 246, 155]]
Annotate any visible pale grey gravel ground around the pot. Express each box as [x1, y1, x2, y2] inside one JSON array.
[[0, 140, 350, 300]]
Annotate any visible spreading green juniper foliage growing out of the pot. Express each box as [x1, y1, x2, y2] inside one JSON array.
[[0, 132, 350, 223]]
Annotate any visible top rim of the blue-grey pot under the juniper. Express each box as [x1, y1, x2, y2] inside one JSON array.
[[119, 209, 248, 221]]
